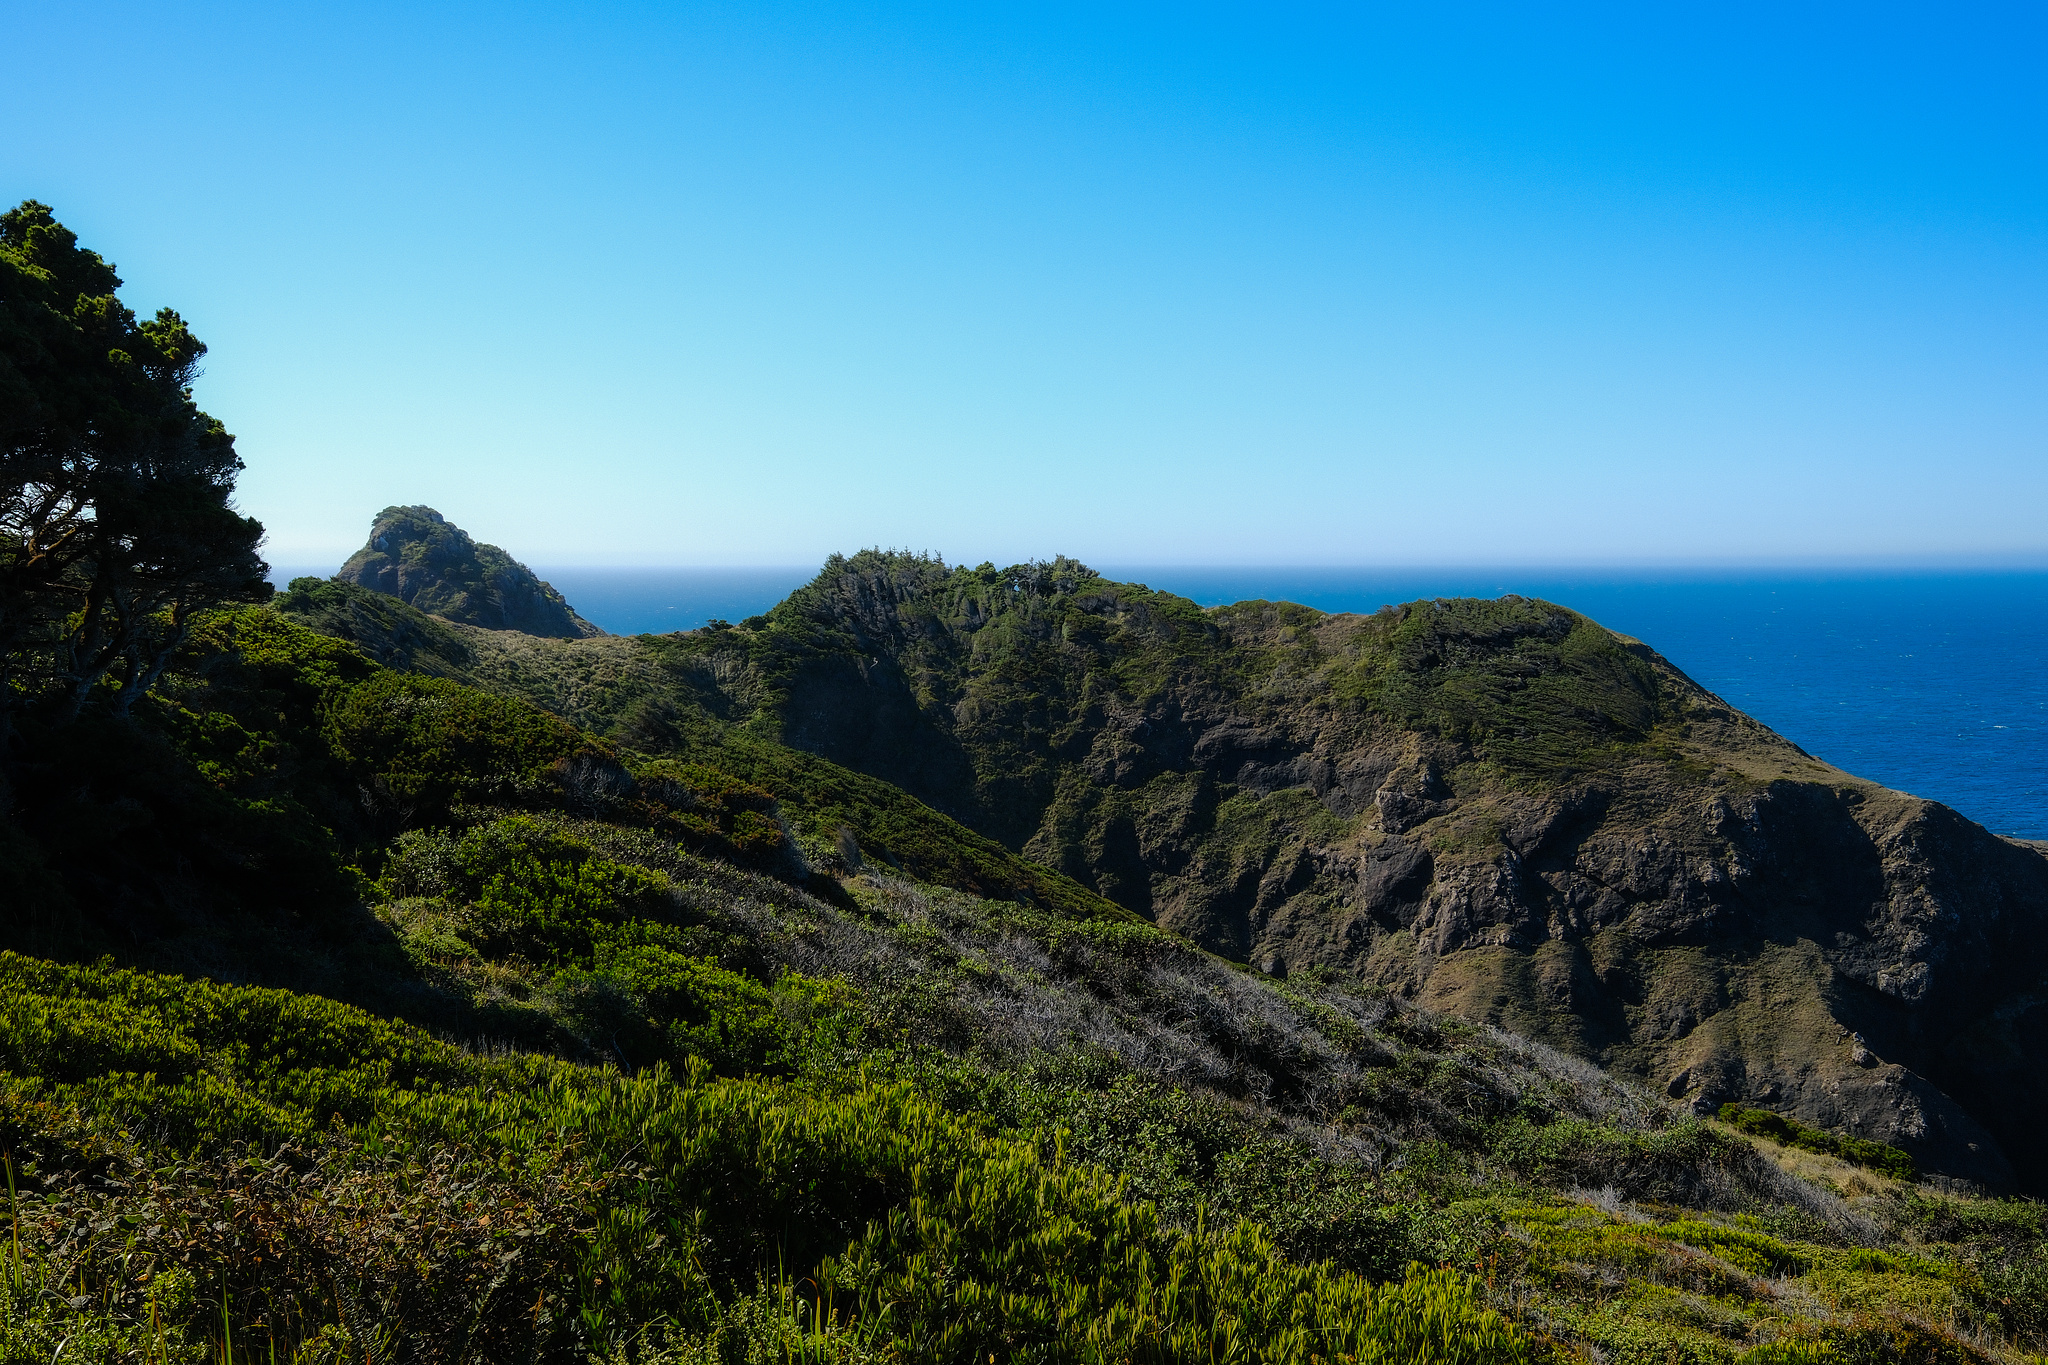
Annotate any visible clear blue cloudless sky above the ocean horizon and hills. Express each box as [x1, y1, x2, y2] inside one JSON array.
[[0, 0, 2048, 565]]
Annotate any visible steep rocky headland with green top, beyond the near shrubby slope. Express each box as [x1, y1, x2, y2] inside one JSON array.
[[280, 553, 2048, 1189]]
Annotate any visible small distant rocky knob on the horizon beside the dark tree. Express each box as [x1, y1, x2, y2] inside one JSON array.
[[334, 508, 604, 641]]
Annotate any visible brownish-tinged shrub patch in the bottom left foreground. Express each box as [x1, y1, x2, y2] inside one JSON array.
[[23, 1138, 602, 1361]]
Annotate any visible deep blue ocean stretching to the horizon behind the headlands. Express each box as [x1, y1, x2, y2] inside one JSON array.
[[276, 565, 2048, 839]]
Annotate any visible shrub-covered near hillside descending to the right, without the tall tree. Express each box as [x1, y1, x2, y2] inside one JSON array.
[[0, 612, 2044, 1361]]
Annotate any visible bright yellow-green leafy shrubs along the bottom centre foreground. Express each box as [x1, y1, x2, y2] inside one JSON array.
[[387, 1074, 1530, 1361]]
